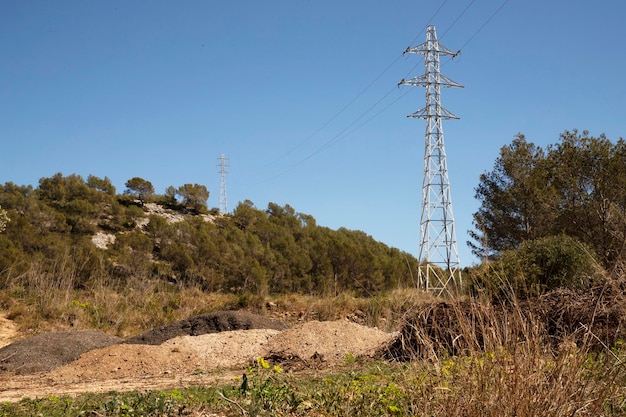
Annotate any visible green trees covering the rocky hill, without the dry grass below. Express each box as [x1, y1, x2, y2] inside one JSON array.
[[0, 173, 418, 295]]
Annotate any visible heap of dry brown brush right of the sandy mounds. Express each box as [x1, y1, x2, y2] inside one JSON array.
[[386, 282, 626, 360]]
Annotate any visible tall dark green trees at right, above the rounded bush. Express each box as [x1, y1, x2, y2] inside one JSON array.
[[469, 130, 626, 272]]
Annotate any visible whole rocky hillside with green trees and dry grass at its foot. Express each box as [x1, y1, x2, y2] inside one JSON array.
[[0, 173, 418, 334]]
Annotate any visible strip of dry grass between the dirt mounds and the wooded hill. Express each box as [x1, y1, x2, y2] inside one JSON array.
[[0, 264, 433, 337]]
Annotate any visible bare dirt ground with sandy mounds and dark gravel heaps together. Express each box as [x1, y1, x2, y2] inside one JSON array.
[[0, 312, 391, 402]]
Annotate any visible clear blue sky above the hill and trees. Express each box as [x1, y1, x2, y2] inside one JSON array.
[[0, 0, 626, 265]]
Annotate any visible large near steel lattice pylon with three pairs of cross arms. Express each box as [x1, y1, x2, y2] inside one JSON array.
[[399, 25, 463, 295]]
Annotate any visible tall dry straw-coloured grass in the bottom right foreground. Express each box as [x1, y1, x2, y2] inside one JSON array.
[[399, 336, 626, 417]]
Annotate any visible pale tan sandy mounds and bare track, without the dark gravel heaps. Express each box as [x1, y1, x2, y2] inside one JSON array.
[[0, 320, 390, 401]]
